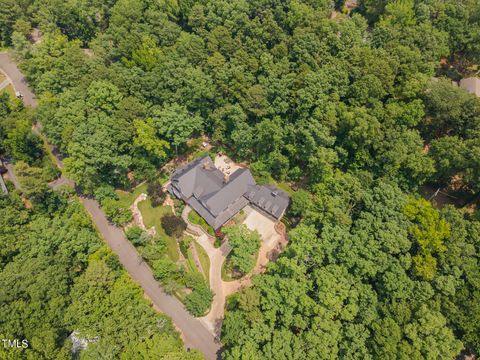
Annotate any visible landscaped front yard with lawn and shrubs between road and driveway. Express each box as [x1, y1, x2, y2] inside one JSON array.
[[114, 184, 213, 316]]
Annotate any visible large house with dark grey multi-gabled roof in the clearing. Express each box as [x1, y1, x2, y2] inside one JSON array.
[[168, 156, 290, 230]]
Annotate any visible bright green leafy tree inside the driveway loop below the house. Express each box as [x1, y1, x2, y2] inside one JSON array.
[[222, 225, 260, 274]]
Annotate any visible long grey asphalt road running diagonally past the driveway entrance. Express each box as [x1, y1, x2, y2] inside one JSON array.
[[0, 53, 220, 360]]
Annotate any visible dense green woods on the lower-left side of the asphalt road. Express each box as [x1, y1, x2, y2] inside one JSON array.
[[0, 193, 201, 360]]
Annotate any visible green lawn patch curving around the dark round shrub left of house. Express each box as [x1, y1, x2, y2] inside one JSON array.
[[138, 197, 179, 262]]
